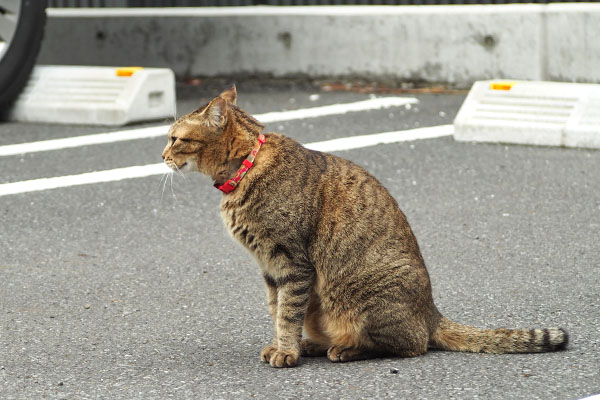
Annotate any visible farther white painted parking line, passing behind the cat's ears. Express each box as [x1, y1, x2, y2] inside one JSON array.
[[0, 97, 419, 157]]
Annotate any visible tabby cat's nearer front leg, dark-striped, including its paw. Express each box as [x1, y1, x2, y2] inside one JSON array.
[[269, 263, 314, 368]]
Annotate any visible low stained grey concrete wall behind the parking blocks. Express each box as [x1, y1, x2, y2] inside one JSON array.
[[39, 4, 600, 86]]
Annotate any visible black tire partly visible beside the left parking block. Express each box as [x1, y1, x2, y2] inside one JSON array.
[[0, 0, 46, 117]]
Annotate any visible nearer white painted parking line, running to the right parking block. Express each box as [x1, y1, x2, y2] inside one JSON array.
[[0, 125, 454, 196]]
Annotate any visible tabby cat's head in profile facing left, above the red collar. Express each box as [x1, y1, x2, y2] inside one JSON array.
[[162, 85, 237, 175]]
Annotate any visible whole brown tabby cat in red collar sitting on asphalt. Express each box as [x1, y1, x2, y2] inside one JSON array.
[[162, 86, 568, 367]]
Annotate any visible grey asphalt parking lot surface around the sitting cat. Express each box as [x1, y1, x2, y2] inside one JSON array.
[[0, 82, 600, 399]]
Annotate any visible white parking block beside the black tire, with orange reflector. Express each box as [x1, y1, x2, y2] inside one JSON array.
[[9, 65, 175, 126]]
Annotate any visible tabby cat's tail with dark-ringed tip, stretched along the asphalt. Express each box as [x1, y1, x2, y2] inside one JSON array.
[[429, 317, 569, 354]]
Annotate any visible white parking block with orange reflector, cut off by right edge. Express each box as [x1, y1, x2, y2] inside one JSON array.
[[454, 81, 600, 148]]
